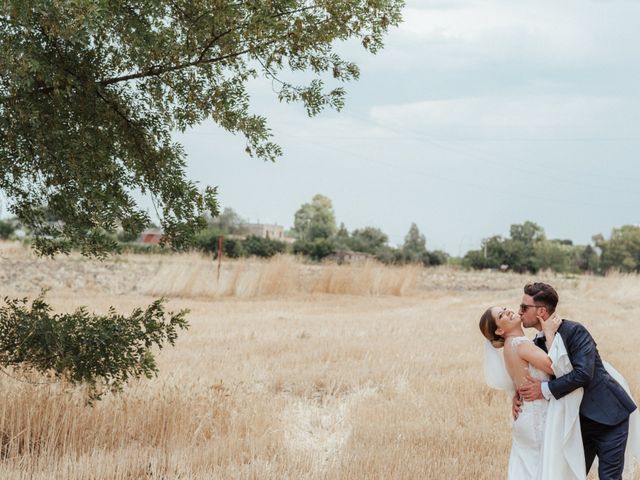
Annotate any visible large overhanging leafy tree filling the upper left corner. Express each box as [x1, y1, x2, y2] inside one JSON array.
[[0, 0, 403, 255]]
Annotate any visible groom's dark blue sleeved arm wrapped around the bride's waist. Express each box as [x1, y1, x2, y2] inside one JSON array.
[[547, 325, 596, 399]]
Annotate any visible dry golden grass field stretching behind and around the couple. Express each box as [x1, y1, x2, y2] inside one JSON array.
[[0, 243, 640, 480]]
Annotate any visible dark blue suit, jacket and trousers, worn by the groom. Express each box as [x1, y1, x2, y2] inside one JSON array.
[[536, 320, 636, 480]]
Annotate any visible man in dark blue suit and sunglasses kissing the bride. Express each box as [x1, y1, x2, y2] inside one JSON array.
[[514, 282, 636, 480]]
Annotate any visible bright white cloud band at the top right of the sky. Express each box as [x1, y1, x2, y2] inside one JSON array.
[[361, 0, 640, 81]]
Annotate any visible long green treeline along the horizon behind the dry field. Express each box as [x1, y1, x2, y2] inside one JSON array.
[[0, 199, 640, 274]]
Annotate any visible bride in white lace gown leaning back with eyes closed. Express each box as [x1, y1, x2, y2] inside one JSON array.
[[480, 307, 640, 480]]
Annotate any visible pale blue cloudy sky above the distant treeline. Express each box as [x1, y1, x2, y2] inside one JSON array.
[[175, 0, 640, 256]]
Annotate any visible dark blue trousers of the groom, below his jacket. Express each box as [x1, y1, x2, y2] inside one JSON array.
[[580, 415, 629, 480]]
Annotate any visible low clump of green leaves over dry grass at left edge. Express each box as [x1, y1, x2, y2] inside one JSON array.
[[0, 294, 188, 402]]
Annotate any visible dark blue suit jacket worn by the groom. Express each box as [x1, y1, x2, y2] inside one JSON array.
[[536, 319, 636, 425]]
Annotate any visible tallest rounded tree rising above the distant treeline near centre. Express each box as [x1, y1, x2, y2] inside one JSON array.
[[293, 194, 336, 242]]
